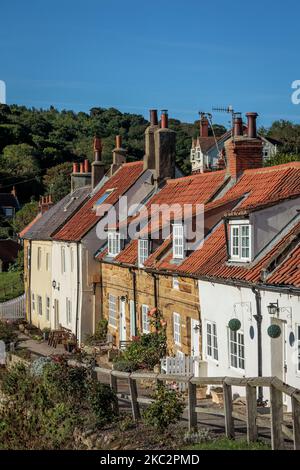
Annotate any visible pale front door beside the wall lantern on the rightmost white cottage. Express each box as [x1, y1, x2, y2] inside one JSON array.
[[271, 318, 287, 382]]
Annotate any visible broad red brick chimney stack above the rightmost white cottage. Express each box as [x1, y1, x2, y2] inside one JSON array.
[[225, 113, 263, 180]]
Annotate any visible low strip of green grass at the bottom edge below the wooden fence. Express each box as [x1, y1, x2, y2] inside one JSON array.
[[187, 437, 271, 450]]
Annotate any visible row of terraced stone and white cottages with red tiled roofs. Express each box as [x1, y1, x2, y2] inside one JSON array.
[[21, 111, 300, 408]]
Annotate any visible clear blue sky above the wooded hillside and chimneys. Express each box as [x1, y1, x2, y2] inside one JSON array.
[[0, 0, 300, 125]]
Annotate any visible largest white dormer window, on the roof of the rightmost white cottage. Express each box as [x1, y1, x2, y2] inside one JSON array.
[[229, 220, 251, 262]]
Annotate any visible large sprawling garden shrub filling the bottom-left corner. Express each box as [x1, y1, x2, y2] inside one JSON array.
[[0, 361, 116, 449]]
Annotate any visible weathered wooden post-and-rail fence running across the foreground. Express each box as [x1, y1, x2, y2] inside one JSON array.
[[94, 367, 300, 450]]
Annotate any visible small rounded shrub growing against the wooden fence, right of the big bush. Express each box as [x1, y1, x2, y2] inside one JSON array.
[[143, 385, 185, 431]]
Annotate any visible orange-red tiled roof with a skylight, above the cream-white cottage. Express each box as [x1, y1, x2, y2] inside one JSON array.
[[53, 161, 143, 241]]
